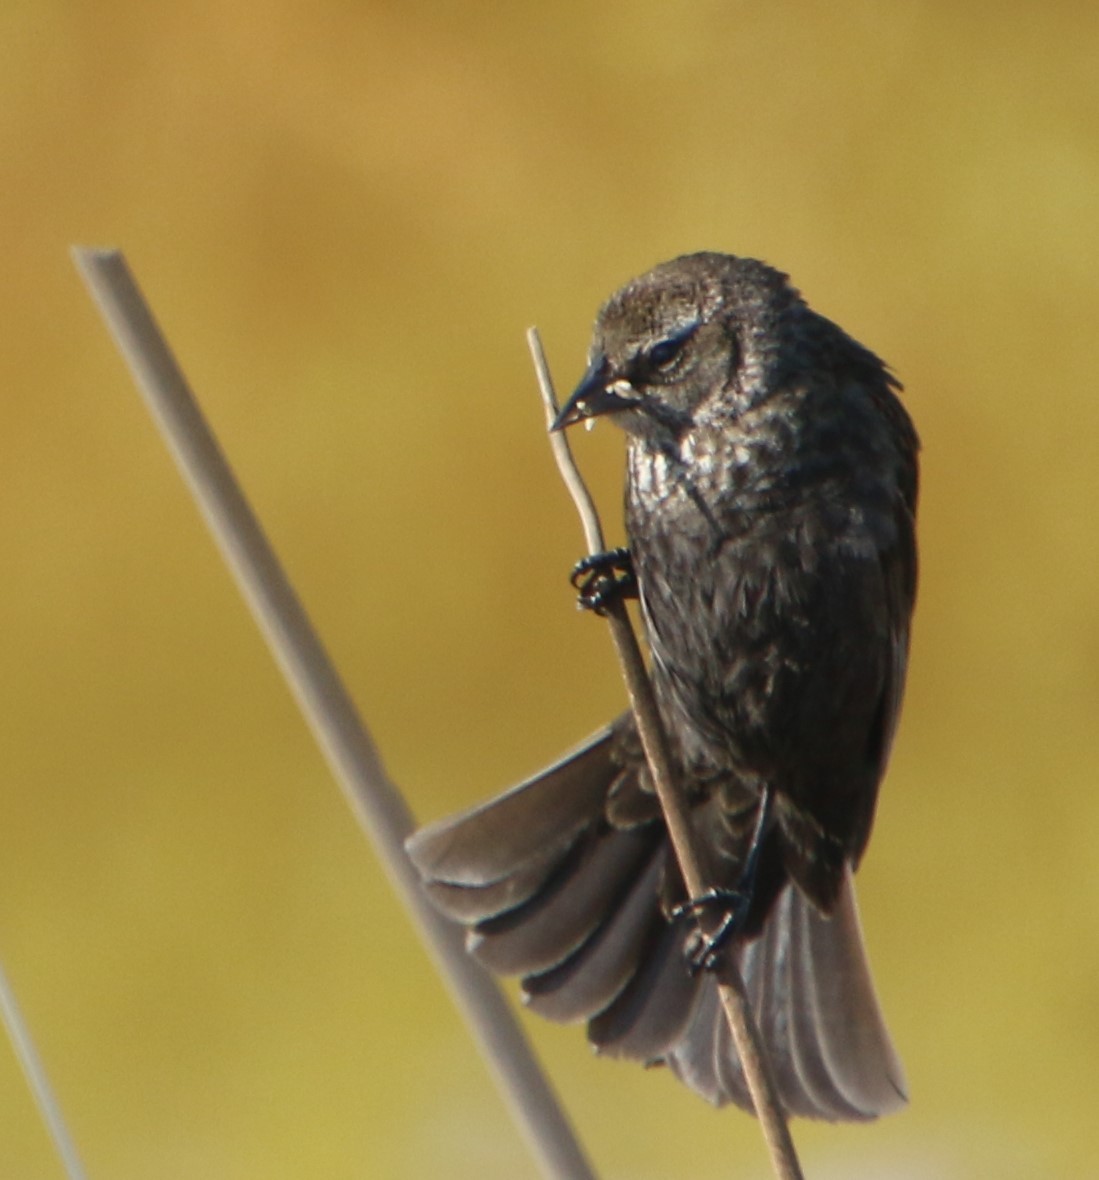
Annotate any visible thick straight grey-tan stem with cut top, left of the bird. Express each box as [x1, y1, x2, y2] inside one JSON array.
[[73, 248, 594, 1180]]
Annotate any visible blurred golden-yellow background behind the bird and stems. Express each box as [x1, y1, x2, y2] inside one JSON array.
[[0, 0, 1099, 1180]]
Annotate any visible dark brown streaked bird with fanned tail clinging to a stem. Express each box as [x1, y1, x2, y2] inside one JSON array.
[[407, 253, 920, 1122]]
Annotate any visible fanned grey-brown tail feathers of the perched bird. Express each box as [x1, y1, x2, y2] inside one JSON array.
[[407, 722, 905, 1121]]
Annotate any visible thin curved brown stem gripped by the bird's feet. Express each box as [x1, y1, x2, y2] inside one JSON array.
[[526, 328, 802, 1180]]
